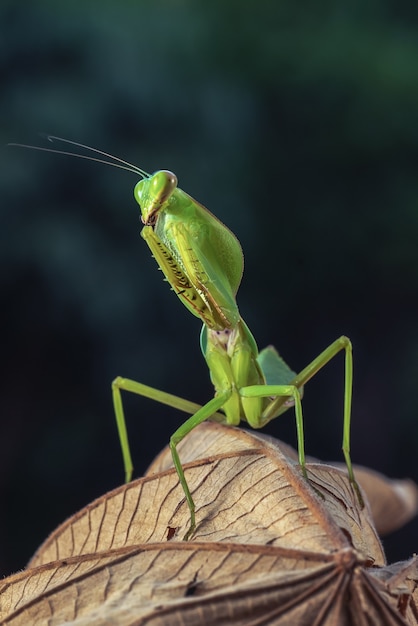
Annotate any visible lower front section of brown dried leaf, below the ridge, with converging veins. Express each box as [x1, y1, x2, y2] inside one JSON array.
[[0, 543, 418, 626]]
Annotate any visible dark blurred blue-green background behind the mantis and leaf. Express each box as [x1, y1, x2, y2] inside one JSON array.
[[0, 0, 418, 574]]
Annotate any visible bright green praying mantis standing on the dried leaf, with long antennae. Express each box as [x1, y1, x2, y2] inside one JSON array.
[[9, 136, 363, 540]]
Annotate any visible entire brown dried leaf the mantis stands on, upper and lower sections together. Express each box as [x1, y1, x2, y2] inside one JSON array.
[[0, 423, 418, 626]]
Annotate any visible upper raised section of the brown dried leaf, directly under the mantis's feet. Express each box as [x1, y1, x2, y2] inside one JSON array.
[[29, 423, 385, 567]]
